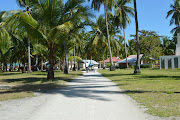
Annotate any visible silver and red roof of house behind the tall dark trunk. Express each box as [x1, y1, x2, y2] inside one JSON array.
[[117, 54, 143, 63]]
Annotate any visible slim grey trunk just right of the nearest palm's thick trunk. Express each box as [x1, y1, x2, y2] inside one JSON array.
[[64, 40, 69, 74]]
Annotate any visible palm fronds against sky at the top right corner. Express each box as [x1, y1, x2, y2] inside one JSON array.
[[166, 0, 180, 33]]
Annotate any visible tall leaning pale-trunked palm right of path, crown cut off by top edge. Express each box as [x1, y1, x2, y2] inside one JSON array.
[[89, 0, 116, 71]]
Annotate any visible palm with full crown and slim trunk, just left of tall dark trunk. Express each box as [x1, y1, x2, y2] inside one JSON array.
[[115, 0, 134, 68]]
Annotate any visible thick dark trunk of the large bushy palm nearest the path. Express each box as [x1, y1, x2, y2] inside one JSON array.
[[47, 43, 54, 81]]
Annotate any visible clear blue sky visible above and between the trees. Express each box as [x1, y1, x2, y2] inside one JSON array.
[[0, 0, 174, 40]]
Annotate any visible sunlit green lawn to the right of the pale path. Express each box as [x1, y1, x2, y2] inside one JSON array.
[[99, 69, 180, 117]]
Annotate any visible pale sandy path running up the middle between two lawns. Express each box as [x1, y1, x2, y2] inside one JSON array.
[[0, 72, 160, 120]]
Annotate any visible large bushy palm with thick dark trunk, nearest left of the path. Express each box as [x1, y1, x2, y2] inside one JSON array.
[[6, 0, 91, 81]]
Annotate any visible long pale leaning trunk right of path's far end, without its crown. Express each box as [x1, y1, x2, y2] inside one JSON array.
[[104, 0, 115, 71]]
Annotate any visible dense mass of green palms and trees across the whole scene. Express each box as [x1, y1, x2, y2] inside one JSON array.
[[0, 0, 177, 80]]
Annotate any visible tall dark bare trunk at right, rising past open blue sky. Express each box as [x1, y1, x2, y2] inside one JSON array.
[[134, 0, 141, 73]]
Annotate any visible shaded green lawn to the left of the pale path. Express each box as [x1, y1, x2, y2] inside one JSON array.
[[0, 71, 82, 101]]
